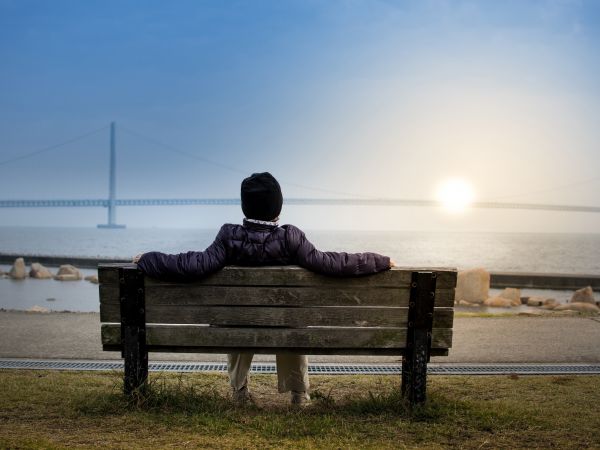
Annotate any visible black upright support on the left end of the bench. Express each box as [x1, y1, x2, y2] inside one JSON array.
[[118, 266, 148, 394]]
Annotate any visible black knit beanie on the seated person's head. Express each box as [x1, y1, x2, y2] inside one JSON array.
[[242, 172, 283, 220]]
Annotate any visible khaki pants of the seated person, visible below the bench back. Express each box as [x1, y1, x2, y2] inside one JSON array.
[[227, 353, 310, 393]]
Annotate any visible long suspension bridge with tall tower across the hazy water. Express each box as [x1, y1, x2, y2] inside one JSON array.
[[0, 122, 600, 228]]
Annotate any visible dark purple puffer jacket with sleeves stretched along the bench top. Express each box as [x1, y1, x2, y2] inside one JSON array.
[[138, 220, 390, 281]]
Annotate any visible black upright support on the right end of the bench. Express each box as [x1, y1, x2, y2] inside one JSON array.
[[402, 272, 437, 404]]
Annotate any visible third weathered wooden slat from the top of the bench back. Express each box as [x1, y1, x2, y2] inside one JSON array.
[[100, 304, 454, 328]]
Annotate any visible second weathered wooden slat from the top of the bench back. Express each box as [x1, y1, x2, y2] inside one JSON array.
[[100, 283, 454, 307]]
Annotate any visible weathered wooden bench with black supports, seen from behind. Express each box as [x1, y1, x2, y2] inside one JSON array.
[[98, 264, 456, 404]]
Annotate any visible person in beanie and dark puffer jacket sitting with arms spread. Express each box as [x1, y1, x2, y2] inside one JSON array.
[[134, 172, 394, 405]]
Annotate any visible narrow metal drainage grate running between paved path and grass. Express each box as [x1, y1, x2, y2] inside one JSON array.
[[0, 359, 600, 375]]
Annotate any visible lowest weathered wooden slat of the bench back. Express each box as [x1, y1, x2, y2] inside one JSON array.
[[102, 324, 452, 353]]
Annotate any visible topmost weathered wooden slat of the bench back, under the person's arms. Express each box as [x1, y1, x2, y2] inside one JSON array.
[[98, 264, 456, 288]]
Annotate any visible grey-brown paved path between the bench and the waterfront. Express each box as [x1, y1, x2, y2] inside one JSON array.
[[0, 311, 600, 363]]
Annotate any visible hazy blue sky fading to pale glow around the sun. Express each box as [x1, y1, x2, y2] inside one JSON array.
[[0, 0, 600, 232]]
